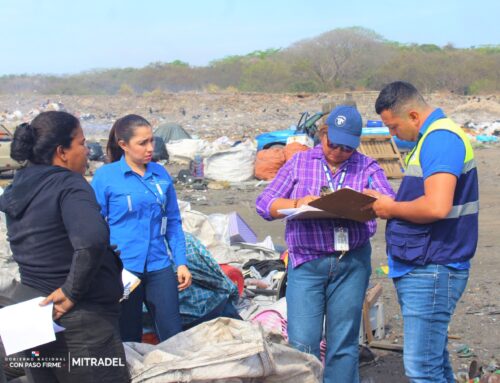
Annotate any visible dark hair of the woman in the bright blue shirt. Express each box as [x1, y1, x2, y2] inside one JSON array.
[[106, 114, 151, 162]]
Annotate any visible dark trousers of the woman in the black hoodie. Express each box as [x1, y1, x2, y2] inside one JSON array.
[[25, 304, 130, 383]]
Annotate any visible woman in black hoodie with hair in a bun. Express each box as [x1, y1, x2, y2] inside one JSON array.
[[0, 112, 129, 382]]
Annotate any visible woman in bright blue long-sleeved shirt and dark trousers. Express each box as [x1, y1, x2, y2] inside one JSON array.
[[92, 114, 191, 342]]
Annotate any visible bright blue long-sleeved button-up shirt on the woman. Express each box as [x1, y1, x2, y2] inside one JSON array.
[[92, 157, 186, 273]]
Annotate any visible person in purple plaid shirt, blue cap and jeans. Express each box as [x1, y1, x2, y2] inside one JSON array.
[[256, 106, 394, 383]]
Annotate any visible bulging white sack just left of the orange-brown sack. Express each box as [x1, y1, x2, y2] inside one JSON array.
[[205, 144, 257, 182]]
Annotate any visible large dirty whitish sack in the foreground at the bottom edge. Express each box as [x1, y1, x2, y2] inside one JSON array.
[[124, 318, 322, 383]]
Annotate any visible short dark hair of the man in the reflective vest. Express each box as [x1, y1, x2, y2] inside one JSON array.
[[375, 81, 426, 114]]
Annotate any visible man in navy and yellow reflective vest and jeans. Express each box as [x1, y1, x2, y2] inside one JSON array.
[[366, 81, 479, 382]]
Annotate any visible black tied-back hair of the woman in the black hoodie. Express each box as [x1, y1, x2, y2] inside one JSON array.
[[10, 111, 80, 165]]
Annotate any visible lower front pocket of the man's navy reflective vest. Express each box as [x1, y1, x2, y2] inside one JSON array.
[[386, 221, 431, 265]]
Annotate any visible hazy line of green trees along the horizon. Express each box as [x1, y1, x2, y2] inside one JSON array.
[[0, 27, 500, 95]]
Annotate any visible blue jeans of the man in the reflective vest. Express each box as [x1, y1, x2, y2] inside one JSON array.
[[394, 264, 469, 383]]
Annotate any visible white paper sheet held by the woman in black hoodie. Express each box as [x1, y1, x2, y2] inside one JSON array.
[[0, 297, 56, 355]]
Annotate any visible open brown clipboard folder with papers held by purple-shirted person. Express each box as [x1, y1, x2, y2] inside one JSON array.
[[279, 188, 376, 222]]
